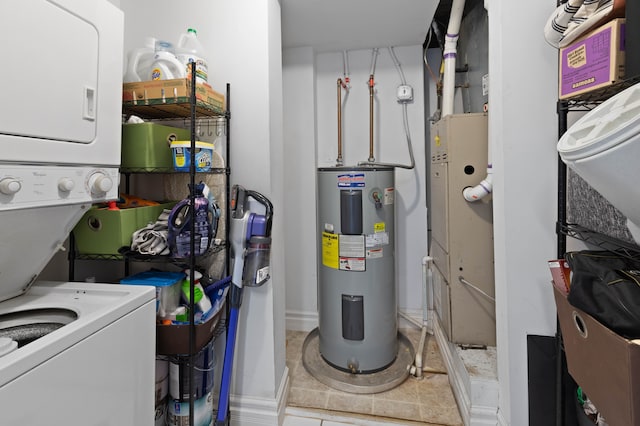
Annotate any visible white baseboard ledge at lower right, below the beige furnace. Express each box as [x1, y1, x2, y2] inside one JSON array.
[[429, 311, 498, 426]]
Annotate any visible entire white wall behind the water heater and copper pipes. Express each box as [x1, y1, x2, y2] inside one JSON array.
[[283, 46, 427, 330]]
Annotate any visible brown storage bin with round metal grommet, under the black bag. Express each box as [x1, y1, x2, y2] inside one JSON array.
[[553, 286, 640, 426]]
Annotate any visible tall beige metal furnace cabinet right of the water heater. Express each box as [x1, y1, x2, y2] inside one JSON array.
[[429, 114, 496, 346]]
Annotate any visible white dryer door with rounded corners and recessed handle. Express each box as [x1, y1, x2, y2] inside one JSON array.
[[0, 0, 99, 143]]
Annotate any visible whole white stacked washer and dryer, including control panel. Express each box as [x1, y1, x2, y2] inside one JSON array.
[[0, 0, 155, 425]]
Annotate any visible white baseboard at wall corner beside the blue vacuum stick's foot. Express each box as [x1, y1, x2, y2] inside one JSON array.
[[229, 367, 290, 426]]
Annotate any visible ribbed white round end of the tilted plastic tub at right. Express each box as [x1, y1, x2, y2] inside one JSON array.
[[557, 84, 640, 161]]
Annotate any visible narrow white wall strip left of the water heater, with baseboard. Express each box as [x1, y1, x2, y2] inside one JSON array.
[[282, 47, 318, 330]]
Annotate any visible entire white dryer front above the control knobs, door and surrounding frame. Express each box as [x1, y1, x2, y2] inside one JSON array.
[[0, 0, 124, 166]]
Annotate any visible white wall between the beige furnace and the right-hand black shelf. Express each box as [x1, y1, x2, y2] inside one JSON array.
[[486, 0, 558, 426]]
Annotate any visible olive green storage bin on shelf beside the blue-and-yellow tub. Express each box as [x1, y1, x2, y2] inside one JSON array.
[[120, 123, 191, 172]]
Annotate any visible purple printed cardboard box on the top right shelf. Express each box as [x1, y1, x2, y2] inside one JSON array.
[[559, 19, 625, 99]]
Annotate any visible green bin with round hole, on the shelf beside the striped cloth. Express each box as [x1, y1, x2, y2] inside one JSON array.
[[73, 202, 175, 255]]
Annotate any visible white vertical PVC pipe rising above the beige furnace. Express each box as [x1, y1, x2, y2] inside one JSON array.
[[442, 0, 465, 117]]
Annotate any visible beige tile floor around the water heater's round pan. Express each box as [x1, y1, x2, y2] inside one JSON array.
[[287, 329, 462, 426]]
